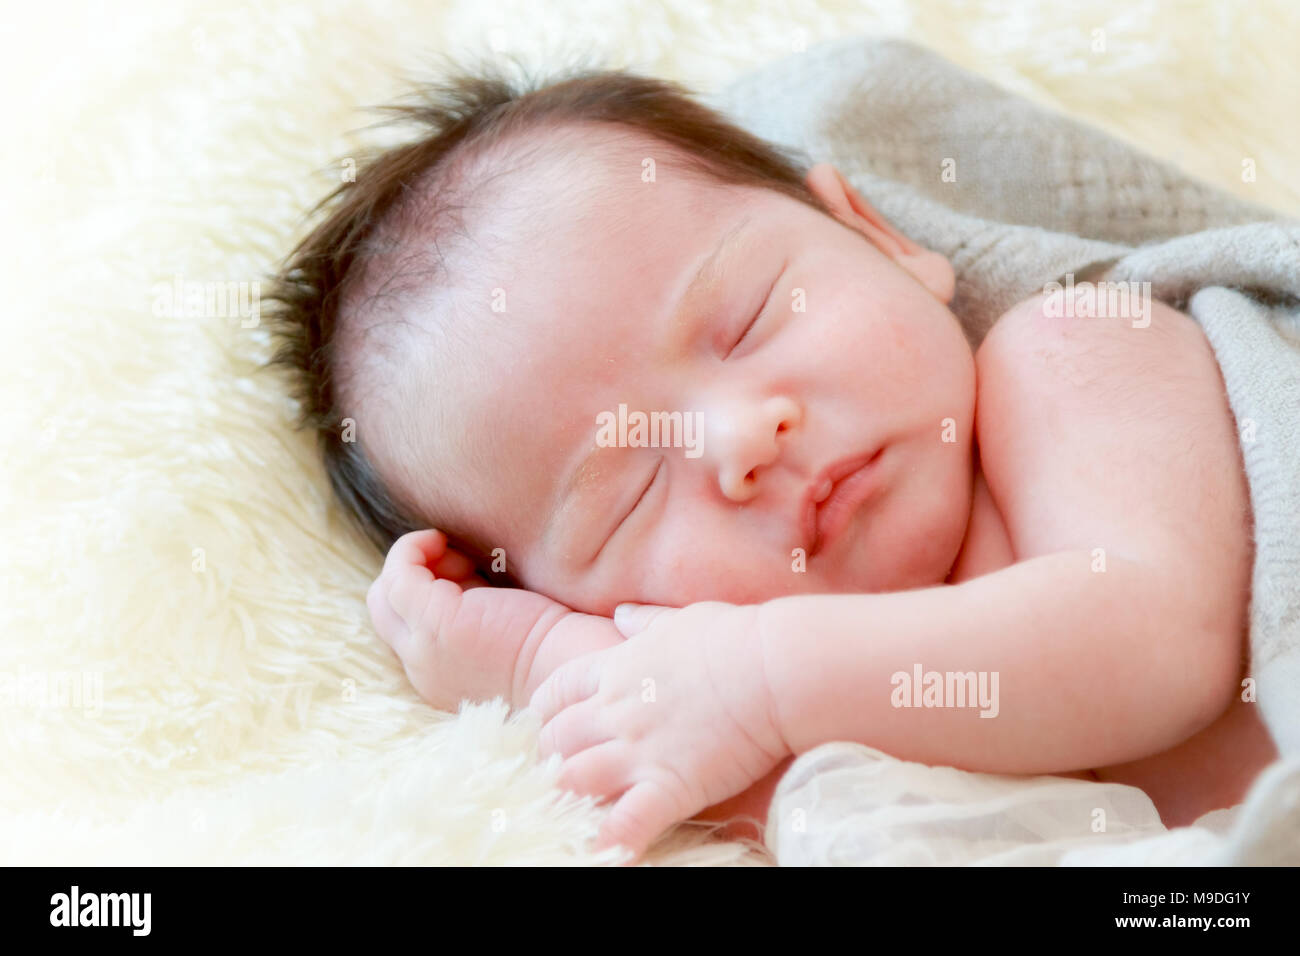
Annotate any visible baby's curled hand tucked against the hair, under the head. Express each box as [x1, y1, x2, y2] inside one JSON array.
[[365, 529, 577, 710]]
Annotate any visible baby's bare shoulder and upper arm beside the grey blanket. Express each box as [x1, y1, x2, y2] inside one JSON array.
[[975, 284, 1249, 574]]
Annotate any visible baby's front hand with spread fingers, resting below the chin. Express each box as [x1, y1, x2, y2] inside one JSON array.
[[528, 602, 788, 858]]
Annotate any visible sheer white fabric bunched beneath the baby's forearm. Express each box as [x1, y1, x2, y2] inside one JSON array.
[[766, 743, 1240, 866]]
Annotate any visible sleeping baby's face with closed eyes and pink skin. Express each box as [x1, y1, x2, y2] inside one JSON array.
[[400, 134, 975, 614]]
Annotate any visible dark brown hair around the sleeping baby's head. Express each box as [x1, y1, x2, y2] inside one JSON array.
[[264, 54, 827, 584]]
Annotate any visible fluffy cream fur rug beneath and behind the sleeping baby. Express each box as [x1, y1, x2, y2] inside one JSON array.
[[0, 0, 1300, 865]]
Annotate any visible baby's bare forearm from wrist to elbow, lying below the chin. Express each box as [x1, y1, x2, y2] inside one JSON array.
[[762, 551, 1239, 774]]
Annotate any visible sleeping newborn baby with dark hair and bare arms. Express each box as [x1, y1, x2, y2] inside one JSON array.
[[273, 73, 1275, 855]]
